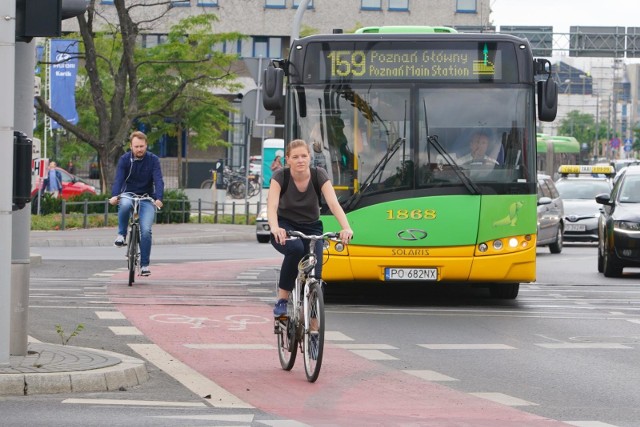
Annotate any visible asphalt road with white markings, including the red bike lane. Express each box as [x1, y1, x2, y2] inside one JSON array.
[[5, 242, 640, 427]]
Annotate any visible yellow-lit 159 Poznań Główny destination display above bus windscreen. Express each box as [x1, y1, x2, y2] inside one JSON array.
[[326, 46, 501, 81]]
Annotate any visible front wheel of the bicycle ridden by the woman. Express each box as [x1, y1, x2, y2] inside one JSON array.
[[303, 280, 324, 382]]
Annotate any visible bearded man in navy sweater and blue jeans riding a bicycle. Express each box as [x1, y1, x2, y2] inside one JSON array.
[[109, 131, 164, 276]]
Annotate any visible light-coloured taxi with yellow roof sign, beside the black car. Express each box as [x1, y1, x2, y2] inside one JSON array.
[[556, 165, 615, 242]]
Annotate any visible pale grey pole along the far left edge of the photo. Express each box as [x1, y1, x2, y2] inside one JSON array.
[[0, 1, 16, 366]]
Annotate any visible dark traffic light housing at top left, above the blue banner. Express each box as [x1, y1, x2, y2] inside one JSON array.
[[15, 0, 87, 42]]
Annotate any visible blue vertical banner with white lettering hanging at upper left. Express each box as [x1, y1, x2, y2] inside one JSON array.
[[49, 40, 78, 129]]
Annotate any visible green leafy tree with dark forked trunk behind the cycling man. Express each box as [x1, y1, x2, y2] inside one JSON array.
[[36, 0, 242, 191]]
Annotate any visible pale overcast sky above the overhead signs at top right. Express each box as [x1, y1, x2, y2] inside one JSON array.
[[490, 0, 640, 33]]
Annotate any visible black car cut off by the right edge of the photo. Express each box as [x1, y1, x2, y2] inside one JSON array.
[[596, 165, 640, 277]]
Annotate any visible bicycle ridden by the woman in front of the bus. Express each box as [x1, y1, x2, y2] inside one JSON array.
[[274, 231, 342, 382]]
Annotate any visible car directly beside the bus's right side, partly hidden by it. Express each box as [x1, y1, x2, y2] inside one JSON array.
[[537, 174, 564, 254]]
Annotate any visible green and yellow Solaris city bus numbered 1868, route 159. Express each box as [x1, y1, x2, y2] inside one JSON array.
[[262, 27, 557, 298]]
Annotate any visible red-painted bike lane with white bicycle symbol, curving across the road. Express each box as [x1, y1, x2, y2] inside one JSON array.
[[109, 259, 567, 427]]
